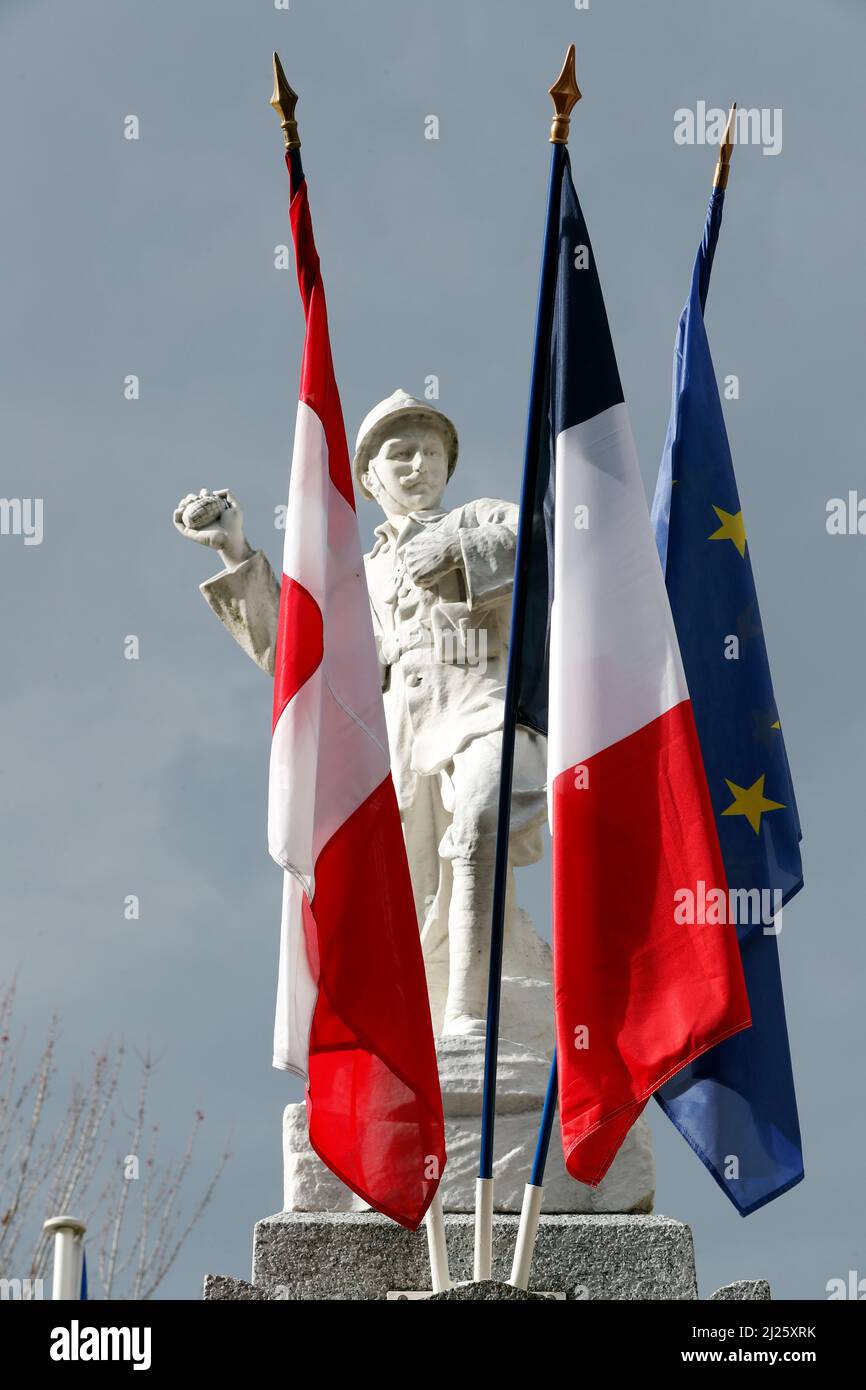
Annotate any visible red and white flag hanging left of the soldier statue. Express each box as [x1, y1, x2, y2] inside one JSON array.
[[268, 152, 445, 1229]]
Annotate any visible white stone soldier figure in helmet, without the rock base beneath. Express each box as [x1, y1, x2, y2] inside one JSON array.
[[175, 391, 549, 1034]]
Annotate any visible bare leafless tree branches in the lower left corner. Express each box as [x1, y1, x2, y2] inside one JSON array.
[[0, 983, 229, 1298]]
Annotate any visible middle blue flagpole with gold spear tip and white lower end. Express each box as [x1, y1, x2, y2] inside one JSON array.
[[474, 44, 580, 1279]]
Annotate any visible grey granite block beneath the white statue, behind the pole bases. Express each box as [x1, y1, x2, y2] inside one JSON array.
[[253, 1212, 698, 1300]]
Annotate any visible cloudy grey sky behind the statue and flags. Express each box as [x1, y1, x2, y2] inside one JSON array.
[[0, 0, 866, 1298]]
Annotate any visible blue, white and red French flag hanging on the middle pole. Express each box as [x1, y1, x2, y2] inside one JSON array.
[[517, 147, 751, 1186]]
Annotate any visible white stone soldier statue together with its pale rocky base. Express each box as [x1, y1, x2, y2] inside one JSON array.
[[174, 391, 653, 1211]]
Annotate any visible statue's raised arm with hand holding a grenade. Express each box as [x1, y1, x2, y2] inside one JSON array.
[[174, 488, 279, 676]]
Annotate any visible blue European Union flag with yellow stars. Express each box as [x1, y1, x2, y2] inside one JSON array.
[[652, 189, 803, 1216]]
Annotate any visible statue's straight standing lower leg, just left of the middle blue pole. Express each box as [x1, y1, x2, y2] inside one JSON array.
[[442, 856, 493, 1036]]
